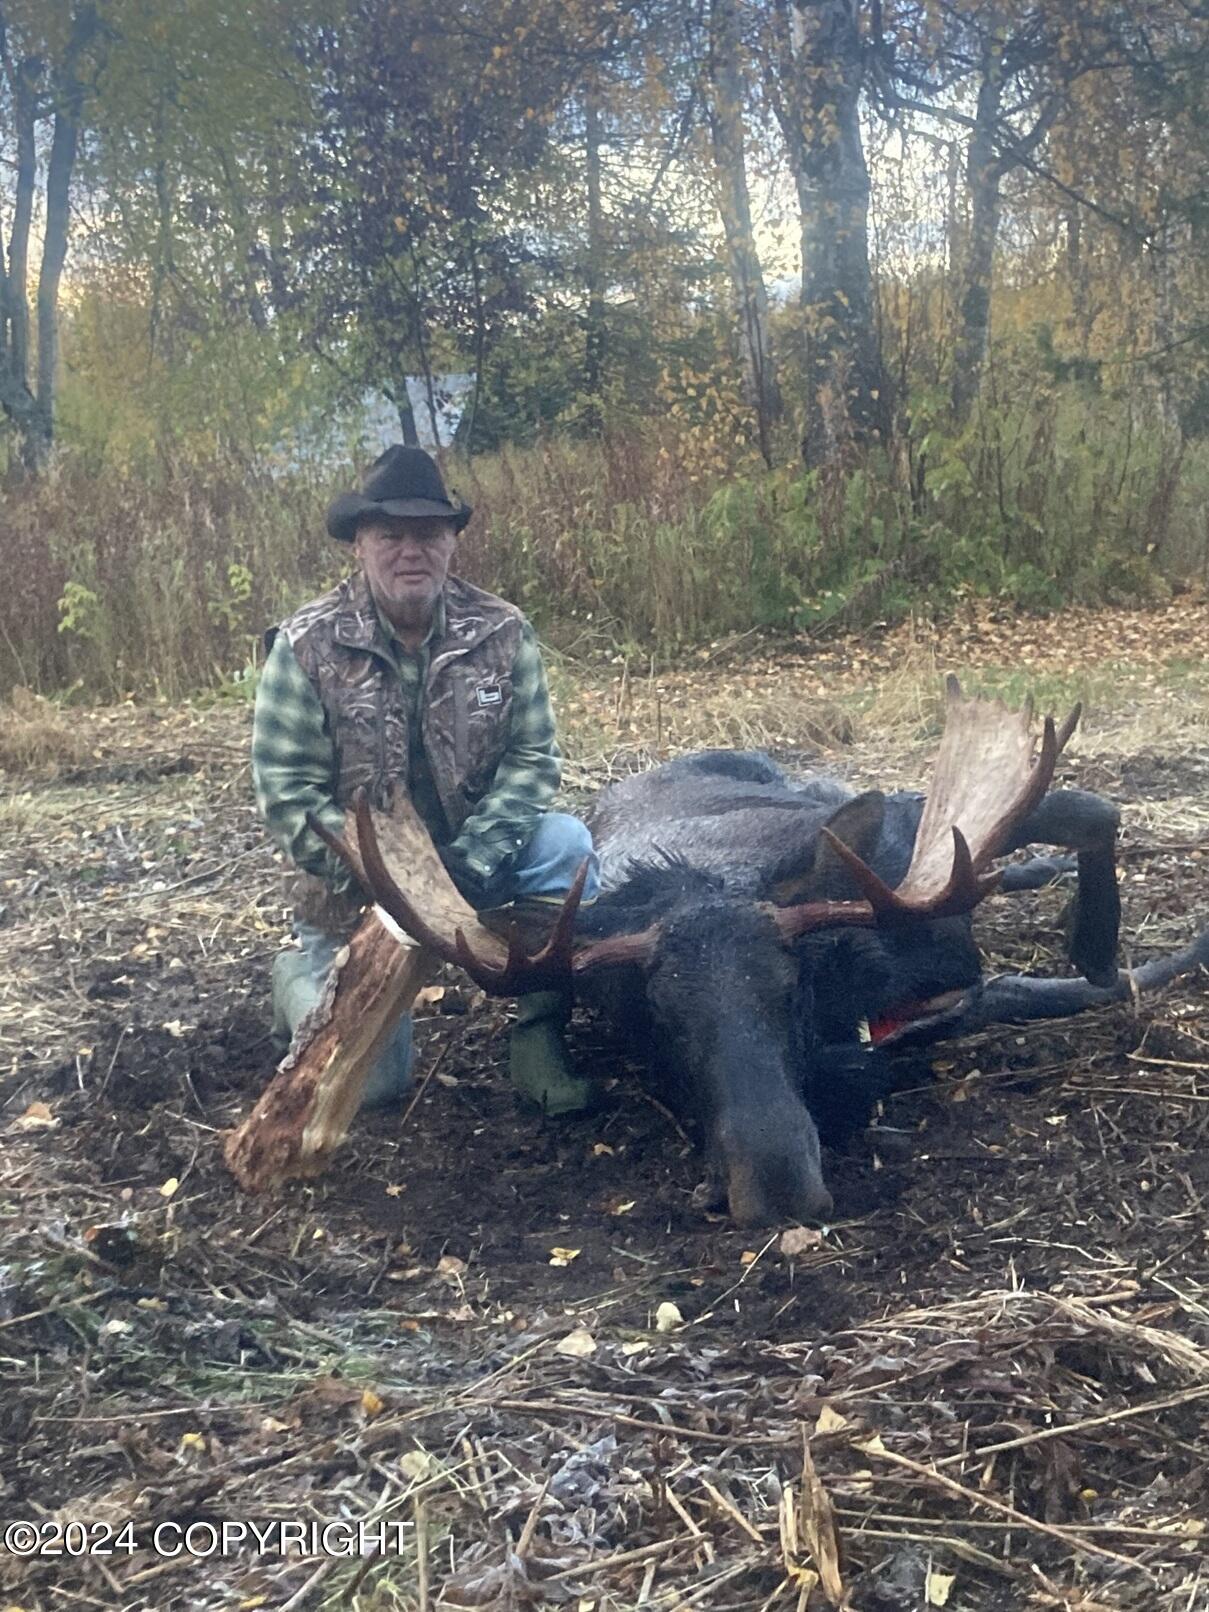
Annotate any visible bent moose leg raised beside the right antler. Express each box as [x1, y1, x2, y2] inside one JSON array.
[[1008, 790, 1120, 988]]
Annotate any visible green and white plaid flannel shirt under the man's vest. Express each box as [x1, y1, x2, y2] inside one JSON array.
[[251, 599, 561, 891]]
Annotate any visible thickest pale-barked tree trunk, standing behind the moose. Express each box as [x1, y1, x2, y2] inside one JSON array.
[[777, 0, 893, 469]]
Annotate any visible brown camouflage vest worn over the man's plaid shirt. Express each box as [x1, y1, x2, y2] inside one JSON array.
[[269, 572, 524, 932]]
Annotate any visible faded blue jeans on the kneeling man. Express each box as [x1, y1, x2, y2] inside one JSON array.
[[272, 811, 600, 1107]]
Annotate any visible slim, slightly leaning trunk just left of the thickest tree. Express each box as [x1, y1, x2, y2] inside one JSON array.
[[709, 0, 780, 466]]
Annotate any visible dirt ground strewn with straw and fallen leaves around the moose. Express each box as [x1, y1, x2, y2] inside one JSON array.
[[0, 605, 1209, 1612]]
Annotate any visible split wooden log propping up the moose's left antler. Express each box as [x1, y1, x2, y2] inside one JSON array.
[[222, 909, 438, 1191]]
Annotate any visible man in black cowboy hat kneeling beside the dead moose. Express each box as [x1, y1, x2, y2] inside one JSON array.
[[251, 447, 598, 1114]]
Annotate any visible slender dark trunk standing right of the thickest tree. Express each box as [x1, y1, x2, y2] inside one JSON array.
[[949, 52, 1004, 421]]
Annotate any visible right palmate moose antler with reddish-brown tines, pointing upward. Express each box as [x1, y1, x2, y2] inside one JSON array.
[[772, 677, 1080, 940]]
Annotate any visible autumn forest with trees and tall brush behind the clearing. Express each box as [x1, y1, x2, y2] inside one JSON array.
[[0, 0, 1209, 698]]
